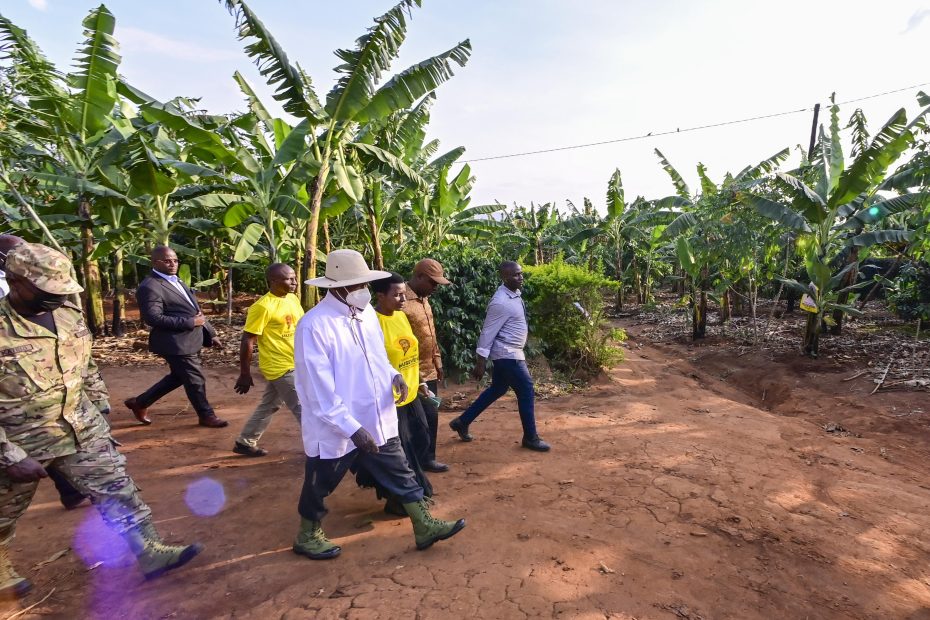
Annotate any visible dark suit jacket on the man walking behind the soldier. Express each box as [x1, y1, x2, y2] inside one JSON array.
[[136, 273, 216, 355]]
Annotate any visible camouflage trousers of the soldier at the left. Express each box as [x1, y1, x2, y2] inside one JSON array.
[[0, 435, 152, 544]]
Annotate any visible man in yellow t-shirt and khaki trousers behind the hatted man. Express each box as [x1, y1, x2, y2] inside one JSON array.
[[233, 263, 304, 456]]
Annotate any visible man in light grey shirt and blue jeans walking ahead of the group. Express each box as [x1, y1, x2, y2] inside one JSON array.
[[449, 261, 549, 452]]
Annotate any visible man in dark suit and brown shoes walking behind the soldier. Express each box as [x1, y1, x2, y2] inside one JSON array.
[[125, 246, 229, 428]]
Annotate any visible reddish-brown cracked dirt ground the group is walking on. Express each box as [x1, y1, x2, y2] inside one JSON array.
[[1, 326, 930, 620]]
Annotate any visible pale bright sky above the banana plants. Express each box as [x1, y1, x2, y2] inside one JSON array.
[[7, 0, 930, 212]]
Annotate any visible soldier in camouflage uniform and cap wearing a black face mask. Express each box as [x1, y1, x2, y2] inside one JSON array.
[[0, 243, 202, 595]]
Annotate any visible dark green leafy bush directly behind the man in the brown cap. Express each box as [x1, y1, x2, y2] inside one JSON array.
[[396, 245, 501, 379]]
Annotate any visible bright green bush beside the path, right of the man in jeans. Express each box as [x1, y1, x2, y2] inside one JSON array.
[[524, 258, 626, 376]]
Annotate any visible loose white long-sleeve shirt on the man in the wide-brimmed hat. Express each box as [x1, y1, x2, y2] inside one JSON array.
[[294, 294, 398, 459]]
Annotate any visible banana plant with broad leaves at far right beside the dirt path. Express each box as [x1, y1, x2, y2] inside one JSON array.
[[740, 94, 930, 357]]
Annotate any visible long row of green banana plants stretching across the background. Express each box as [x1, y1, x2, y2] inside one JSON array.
[[0, 0, 930, 355]]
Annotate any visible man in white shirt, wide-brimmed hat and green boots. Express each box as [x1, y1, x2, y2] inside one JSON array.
[[293, 250, 465, 560]]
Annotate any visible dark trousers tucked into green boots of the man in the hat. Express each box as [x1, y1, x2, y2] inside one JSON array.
[[297, 437, 423, 521]]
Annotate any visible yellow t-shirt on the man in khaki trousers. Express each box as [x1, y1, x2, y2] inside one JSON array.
[[244, 293, 304, 381]]
